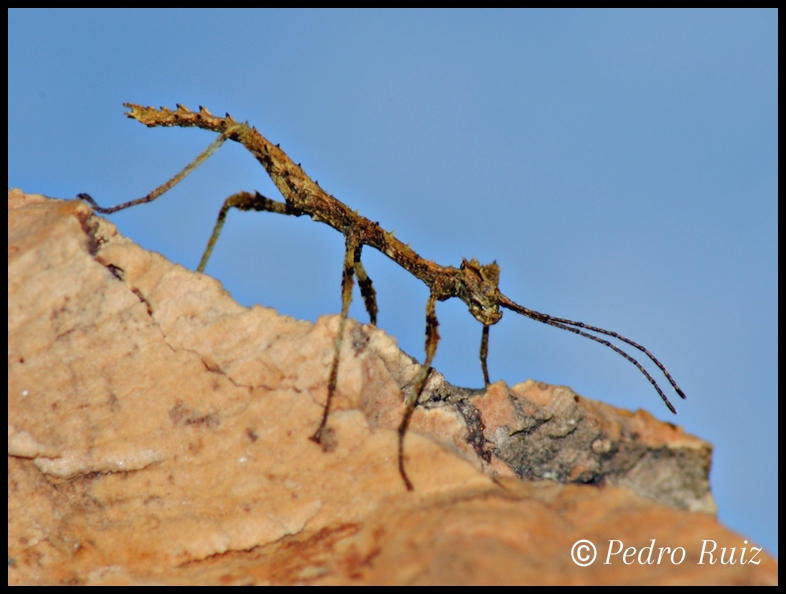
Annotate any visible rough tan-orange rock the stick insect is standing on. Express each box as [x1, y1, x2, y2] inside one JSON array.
[[8, 191, 777, 584]]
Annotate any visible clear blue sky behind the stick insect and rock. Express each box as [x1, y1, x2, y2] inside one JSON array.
[[8, 10, 778, 554]]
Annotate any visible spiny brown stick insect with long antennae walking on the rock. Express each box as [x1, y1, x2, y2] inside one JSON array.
[[78, 103, 685, 491]]
